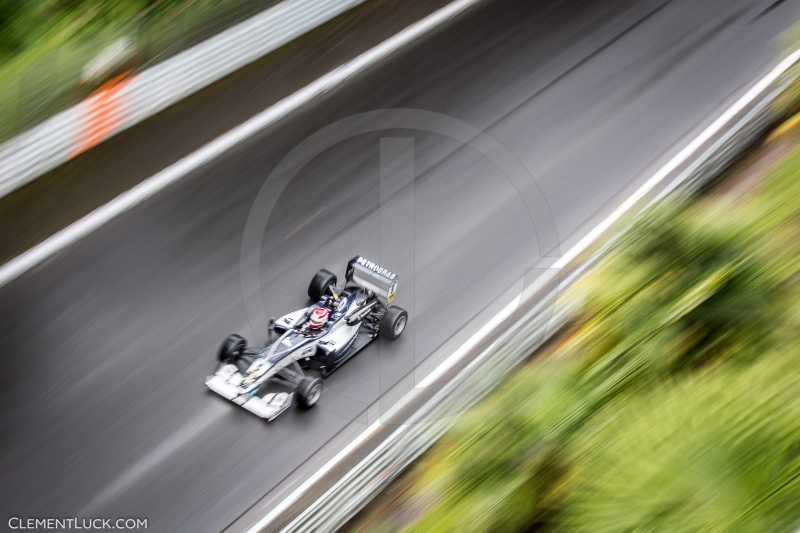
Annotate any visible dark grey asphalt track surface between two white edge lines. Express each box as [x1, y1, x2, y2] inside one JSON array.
[[0, 0, 800, 532]]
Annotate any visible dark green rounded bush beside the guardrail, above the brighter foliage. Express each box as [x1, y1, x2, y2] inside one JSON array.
[[576, 194, 796, 393]]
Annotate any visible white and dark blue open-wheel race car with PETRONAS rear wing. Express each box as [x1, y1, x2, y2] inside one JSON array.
[[206, 256, 408, 421]]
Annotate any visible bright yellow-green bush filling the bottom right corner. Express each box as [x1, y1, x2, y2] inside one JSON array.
[[560, 354, 800, 533]]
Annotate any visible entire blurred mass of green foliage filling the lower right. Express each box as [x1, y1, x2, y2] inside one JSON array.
[[390, 142, 800, 532]]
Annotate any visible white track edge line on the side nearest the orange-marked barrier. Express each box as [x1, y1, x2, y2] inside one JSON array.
[[0, 0, 483, 287]]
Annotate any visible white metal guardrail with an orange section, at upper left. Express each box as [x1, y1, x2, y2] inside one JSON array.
[[0, 0, 365, 197]]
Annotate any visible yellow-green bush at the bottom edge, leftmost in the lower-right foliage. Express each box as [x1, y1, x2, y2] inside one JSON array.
[[414, 364, 584, 532]]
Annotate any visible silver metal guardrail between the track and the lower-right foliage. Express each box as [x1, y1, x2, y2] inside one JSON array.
[[274, 47, 800, 532]]
